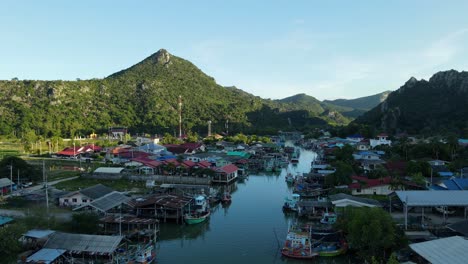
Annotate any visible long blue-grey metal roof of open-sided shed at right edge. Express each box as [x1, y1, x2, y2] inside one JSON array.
[[396, 191, 468, 206]]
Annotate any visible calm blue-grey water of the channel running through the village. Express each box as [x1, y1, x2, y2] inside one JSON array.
[[157, 150, 349, 264]]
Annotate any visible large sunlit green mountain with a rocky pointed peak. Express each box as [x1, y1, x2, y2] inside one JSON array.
[[0, 50, 348, 139]]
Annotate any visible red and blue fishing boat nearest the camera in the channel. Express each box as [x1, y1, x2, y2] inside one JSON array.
[[281, 224, 318, 259]]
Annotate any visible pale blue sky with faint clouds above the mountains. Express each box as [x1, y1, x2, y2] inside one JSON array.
[[0, 0, 468, 100]]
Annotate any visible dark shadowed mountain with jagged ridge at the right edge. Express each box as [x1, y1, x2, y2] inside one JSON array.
[[355, 70, 468, 134]]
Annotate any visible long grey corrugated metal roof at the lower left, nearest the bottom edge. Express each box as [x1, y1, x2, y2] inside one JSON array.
[[44, 232, 123, 254]]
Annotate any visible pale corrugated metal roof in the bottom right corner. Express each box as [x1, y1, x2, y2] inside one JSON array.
[[410, 236, 468, 264]]
